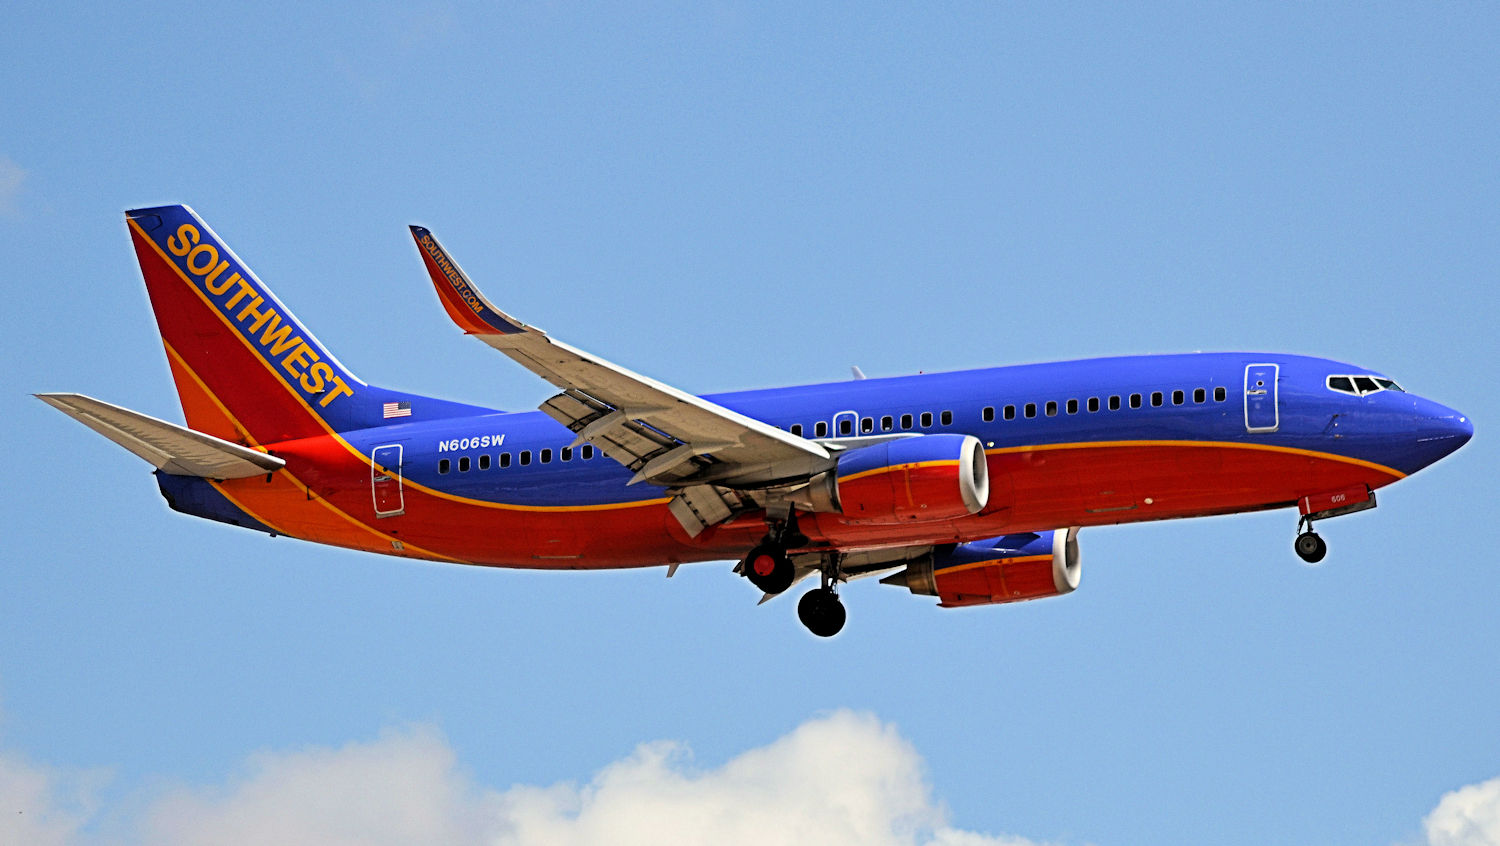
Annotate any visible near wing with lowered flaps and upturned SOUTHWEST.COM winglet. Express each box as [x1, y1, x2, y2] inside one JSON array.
[[411, 227, 833, 534]]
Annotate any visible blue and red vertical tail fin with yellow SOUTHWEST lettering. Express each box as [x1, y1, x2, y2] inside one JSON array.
[[126, 206, 480, 444]]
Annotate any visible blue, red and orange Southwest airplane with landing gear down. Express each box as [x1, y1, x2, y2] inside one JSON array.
[[36, 206, 1473, 638]]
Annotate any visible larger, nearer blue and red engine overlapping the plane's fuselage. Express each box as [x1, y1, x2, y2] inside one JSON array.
[[830, 435, 990, 524]]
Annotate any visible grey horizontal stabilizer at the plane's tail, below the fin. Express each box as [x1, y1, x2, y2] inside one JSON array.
[[36, 393, 287, 479]]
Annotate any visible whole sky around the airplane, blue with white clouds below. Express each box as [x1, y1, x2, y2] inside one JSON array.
[[0, 3, 1500, 845]]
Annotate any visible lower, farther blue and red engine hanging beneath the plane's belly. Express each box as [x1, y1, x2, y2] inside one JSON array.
[[881, 528, 1083, 608]]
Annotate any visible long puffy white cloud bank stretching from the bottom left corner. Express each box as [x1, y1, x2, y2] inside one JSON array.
[[0, 711, 1056, 846]]
